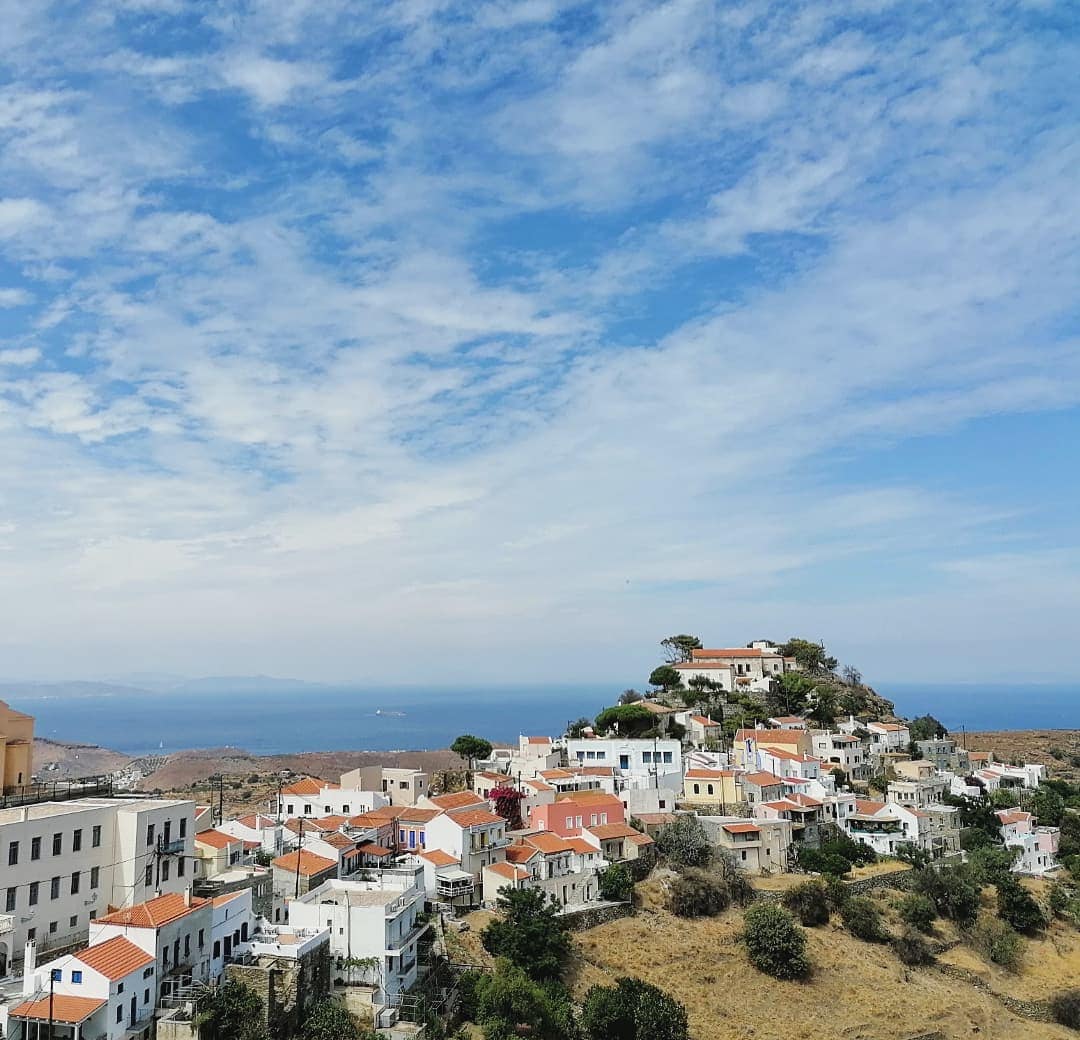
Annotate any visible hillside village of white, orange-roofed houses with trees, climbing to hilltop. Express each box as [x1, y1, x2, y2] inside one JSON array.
[[0, 635, 1080, 1040]]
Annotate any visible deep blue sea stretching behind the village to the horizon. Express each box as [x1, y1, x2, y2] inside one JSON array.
[[5, 683, 1080, 756]]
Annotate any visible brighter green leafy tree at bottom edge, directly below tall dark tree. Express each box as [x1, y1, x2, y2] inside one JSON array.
[[475, 959, 575, 1040]]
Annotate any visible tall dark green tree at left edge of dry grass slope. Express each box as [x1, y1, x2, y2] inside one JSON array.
[[481, 889, 570, 982]]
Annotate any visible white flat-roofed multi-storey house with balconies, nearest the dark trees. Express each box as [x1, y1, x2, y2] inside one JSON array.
[[288, 864, 428, 1004]]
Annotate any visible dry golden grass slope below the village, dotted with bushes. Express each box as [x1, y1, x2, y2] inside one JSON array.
[[450, 874, 1080, 1040]]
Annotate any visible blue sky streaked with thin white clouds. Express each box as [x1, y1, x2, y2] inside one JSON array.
[[0, 0, 1080, 684]]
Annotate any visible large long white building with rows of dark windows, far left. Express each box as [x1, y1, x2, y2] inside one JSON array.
[[0, 798, 194, 977]]
